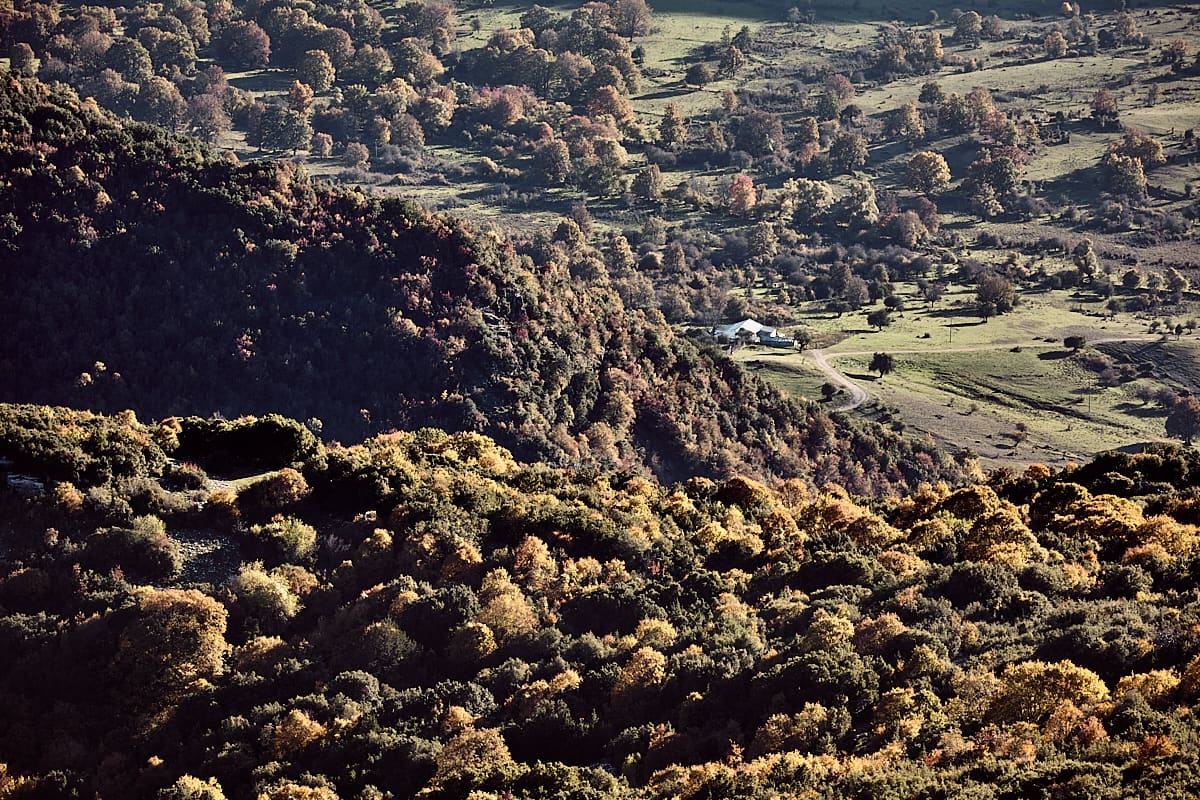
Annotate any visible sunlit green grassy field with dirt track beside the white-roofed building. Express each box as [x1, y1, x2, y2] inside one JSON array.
[[736, 283, 1200, 467]]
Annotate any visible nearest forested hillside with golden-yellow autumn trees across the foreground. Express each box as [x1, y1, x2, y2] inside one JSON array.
[[0, 405, 1200, 800]]
